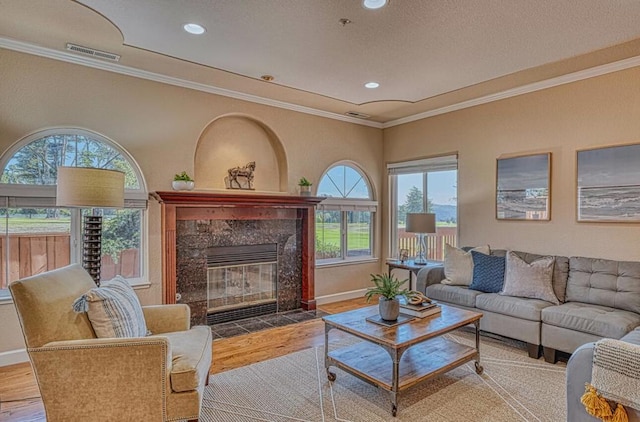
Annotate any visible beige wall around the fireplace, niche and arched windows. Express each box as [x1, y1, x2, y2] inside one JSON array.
[[0, 49, 383, 360]]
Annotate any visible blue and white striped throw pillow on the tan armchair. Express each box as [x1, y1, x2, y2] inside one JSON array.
[[73, 276, 150, 338]]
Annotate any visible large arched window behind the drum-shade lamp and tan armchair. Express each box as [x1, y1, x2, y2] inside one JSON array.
[[0, 128, 148, 297]]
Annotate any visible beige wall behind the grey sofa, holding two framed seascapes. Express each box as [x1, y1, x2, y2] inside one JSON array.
[[383, 68, 640, 260]]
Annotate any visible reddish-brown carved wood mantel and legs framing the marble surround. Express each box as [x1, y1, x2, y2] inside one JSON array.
[[151, 191, 324, 316]]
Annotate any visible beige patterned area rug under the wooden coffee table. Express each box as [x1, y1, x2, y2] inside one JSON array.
[[200, 330, 566, 422]]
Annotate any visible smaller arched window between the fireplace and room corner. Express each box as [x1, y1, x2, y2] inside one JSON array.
[[316, 163, 377, 264]]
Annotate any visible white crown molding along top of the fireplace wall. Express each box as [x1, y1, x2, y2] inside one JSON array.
[[0, 37, 382, 129]]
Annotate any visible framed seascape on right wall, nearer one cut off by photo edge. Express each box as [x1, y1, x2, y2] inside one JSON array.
[[577, 144, 640, 222]]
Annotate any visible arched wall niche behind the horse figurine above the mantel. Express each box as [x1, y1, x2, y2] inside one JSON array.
[[194, 113, 288, 192]]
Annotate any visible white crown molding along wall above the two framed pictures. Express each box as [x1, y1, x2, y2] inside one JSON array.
[[382, 56, 640, 129]]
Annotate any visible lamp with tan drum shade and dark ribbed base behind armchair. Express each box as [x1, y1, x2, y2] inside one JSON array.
[[56, 167, 124, 286]]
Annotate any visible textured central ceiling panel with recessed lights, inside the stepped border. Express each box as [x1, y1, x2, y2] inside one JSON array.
[[80, 0, 640, 104]]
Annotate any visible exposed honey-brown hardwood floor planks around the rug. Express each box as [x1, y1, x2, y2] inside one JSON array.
[[0, 298, 370, 422]]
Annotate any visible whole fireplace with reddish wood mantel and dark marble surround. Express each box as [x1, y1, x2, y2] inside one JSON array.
[[153, 191, 323, 325]]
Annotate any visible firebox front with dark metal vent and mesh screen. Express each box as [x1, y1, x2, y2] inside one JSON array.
[[207, 244, 277, 313]]
